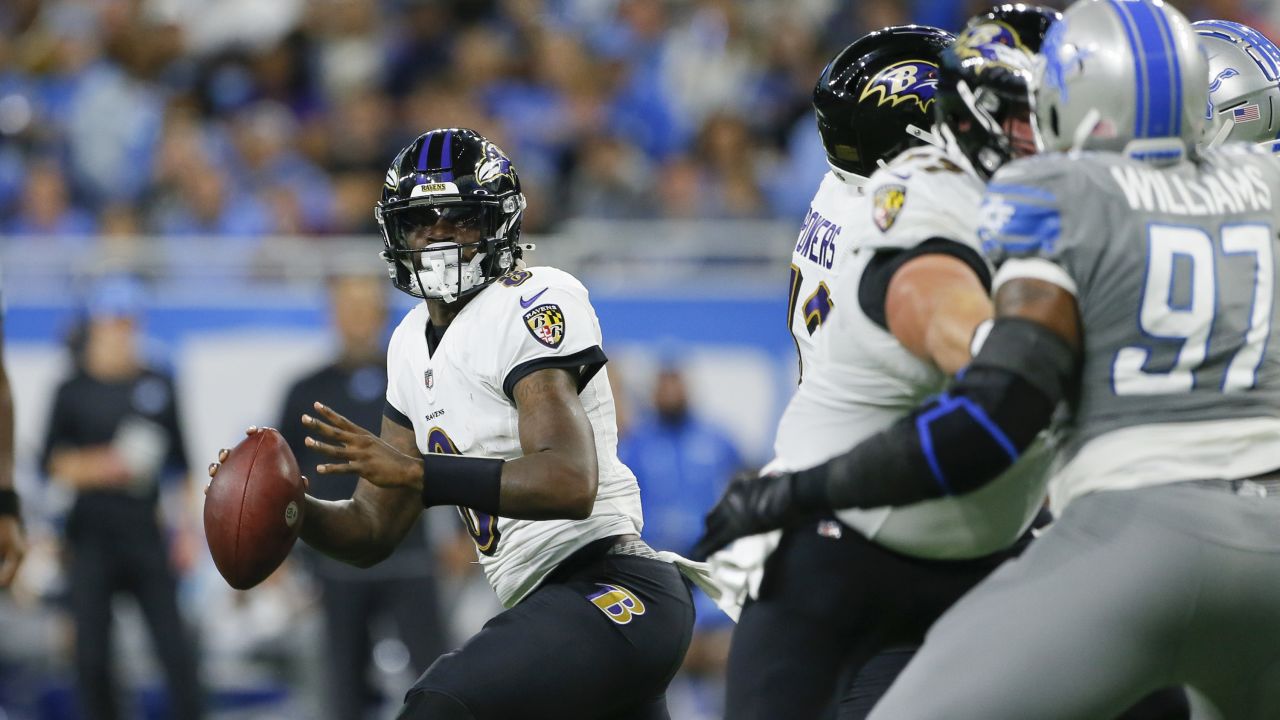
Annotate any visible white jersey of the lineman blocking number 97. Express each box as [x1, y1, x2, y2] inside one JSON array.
[[767, 146, 1047, 559]]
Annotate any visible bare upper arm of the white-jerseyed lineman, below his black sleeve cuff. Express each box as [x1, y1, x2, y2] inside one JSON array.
[[884, 254, 992, 375]]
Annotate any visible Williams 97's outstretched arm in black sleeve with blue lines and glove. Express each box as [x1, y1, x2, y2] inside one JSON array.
[[694, 279, 1080, 557]]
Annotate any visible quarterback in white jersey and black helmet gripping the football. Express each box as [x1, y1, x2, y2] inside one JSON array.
[[220, 128, 694, 720]]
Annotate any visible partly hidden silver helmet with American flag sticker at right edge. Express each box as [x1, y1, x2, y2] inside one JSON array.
[[1192, 20, 1280, 151]]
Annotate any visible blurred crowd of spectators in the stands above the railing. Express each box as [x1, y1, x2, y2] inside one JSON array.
[[0, 0, 1059, 242]]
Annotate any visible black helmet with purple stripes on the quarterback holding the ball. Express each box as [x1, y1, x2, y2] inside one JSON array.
[[374, 128, 527, 302]]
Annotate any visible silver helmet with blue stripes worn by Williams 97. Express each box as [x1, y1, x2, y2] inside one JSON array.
[[1036, 0, 1208, 160]]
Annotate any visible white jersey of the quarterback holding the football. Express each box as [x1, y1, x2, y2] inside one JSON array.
[[387, 268, 643, 607]]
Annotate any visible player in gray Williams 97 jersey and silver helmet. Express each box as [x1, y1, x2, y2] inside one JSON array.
[[696, 0, 1280, 720]]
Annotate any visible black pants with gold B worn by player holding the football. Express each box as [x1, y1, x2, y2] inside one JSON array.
[[399, 545, 694, 720]]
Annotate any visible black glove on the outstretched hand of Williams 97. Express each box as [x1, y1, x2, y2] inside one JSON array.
[[690, 473, 815, 560]]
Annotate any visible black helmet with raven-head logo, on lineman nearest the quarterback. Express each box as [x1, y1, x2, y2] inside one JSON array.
[[813, 26, 955, 177]]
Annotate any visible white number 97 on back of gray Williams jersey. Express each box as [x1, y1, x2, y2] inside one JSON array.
[[1111, 224, 1275, 395]]
